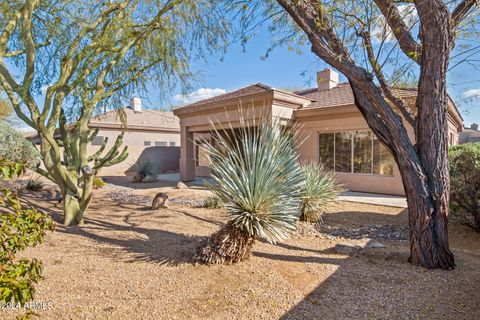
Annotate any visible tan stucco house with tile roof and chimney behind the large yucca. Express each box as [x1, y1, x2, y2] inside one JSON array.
[[174, 69, 463, 195]]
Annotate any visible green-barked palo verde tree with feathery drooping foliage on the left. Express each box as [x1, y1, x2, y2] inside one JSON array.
[[0, 0, 226, 225]]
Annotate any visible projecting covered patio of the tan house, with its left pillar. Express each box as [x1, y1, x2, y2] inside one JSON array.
[[174, 84, 312, 182]]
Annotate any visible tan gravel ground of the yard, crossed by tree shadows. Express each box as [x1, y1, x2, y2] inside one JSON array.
[[4, 182, 480, 319]]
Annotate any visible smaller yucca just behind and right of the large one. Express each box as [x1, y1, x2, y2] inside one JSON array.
[[300, 163, 342, 223]]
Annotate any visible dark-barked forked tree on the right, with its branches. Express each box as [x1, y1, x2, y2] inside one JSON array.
[[234, 0, 478, 269]]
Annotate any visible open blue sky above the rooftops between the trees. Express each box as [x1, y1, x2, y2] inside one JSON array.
[[142, 26, 480, 126]]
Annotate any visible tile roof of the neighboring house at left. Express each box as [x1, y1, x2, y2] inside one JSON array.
[[89, 107, 180, 130]]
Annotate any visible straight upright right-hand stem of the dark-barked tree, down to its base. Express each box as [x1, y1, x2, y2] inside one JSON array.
[[405, 1, 455, 269]]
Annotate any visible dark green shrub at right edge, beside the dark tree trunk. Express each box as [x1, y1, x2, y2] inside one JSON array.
[[448, 143, 480, 231]]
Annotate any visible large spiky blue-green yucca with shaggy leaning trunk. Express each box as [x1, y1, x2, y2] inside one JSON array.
[[196, 117, 303, 264]]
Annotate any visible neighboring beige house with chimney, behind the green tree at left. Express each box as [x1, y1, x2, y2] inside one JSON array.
[[28, 97, 180, 175]]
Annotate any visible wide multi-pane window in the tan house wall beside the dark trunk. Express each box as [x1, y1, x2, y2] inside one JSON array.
[[318, 130, 394, 176]]
